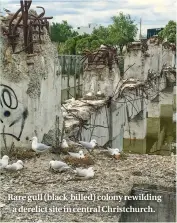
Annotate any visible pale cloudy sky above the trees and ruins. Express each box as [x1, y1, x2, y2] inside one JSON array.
[[0, 0, 176, 35]]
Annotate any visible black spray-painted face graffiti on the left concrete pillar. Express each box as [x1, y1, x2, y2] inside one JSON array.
[[0, 84, 28, 141]]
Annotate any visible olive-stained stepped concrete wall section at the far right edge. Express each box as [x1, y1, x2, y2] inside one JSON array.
[[146, 88, 176, 155]]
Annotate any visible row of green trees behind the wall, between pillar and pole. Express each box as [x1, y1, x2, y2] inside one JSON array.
[[51, 12, 138, 54]]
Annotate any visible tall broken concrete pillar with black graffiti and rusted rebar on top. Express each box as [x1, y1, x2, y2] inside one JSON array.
[[0, 1, 62, 148]]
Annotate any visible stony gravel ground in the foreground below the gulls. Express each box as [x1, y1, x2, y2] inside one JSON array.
[[0, 152, 175, 222]]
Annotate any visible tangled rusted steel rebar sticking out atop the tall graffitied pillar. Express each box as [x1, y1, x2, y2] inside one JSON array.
[[3, 0, 53, 54]]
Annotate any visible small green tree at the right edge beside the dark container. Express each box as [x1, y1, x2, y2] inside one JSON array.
[[158, 20, 176, 43]]
